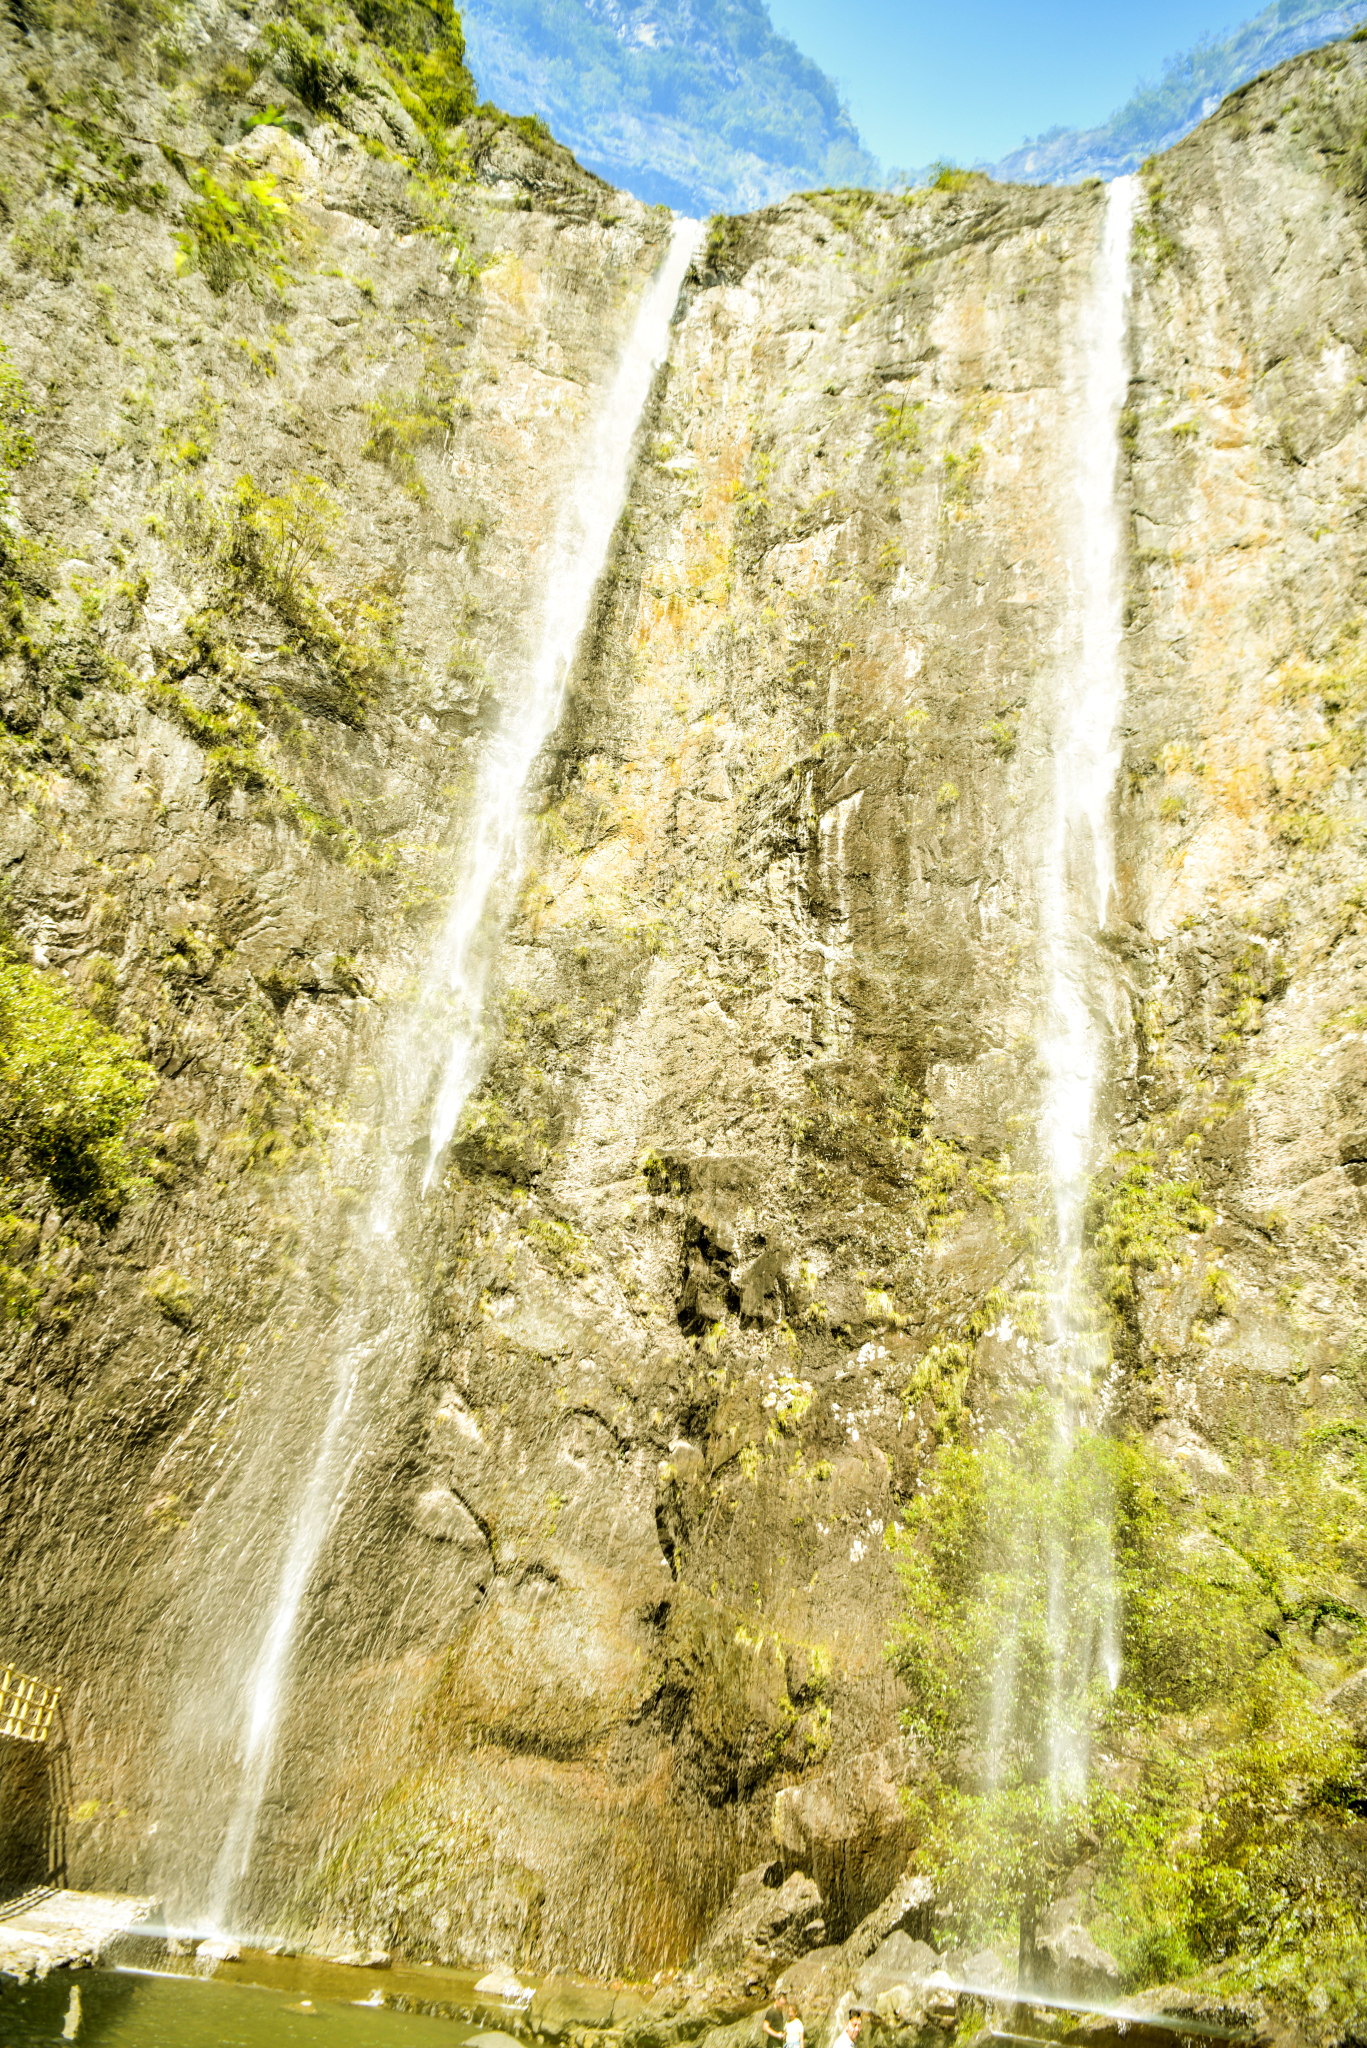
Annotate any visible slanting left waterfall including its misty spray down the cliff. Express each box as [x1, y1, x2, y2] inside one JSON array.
[[154, 221, 699, 1929]]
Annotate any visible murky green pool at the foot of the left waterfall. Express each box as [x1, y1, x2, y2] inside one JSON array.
[[0, 1970, 475, 2048]]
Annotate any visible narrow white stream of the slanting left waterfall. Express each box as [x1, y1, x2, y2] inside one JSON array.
[[187, 219, 701, 1929]]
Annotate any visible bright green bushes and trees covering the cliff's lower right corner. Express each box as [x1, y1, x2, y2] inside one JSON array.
[[889, 1409, 1367, 2019]]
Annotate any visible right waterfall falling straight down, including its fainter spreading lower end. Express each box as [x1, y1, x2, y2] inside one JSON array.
[[988, 178, 1135, 1808]]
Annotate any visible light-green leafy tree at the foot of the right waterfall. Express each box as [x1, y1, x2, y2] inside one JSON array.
[[889, 1403, 1119, 1972]]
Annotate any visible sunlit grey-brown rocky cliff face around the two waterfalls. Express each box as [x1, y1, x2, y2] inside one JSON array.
[[0, 6, 1367, 2015]]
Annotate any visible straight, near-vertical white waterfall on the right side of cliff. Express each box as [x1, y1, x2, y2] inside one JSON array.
[[1037, 178, 1135, 1800]]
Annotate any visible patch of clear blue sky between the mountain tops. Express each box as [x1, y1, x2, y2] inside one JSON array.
[[769, 0, 1258, 166]]
